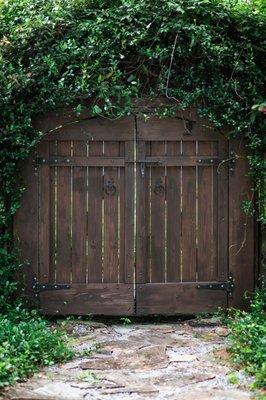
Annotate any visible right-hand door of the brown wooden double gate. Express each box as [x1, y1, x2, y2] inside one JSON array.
[[137, 118, 231, 314]]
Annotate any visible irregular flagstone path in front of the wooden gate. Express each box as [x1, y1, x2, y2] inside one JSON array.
[[2, 320, 253, 400]]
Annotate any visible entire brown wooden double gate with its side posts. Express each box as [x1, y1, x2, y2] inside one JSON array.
[[14, 111, 254, 315]]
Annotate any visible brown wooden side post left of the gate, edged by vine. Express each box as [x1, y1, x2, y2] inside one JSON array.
[[13, 152, 39, 297]]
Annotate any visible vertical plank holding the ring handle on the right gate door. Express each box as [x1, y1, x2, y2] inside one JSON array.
[[151, 142, 165, 282]]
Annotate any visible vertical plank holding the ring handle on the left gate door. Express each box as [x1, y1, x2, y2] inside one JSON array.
[[103, 141, 119, 283]]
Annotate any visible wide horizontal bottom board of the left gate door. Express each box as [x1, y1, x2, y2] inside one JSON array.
[[40, 283, 134, 315]]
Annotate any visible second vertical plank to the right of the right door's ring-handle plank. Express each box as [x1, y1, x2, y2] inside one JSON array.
[[181, 142, 197, 282]]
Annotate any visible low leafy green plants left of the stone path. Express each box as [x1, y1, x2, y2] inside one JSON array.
[[0, 307, 73, 388]]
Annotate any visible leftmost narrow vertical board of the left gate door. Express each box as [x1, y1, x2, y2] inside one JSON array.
[[38, 142, 50, 283]]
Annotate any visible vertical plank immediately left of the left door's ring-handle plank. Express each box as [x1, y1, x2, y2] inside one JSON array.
[[87, 142, 103, 283]]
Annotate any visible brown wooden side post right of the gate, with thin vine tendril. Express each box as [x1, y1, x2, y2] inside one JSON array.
[[229, 140, 254, 308]]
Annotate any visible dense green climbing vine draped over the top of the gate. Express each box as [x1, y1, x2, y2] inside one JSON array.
[[0, 0, 266, 299]]
